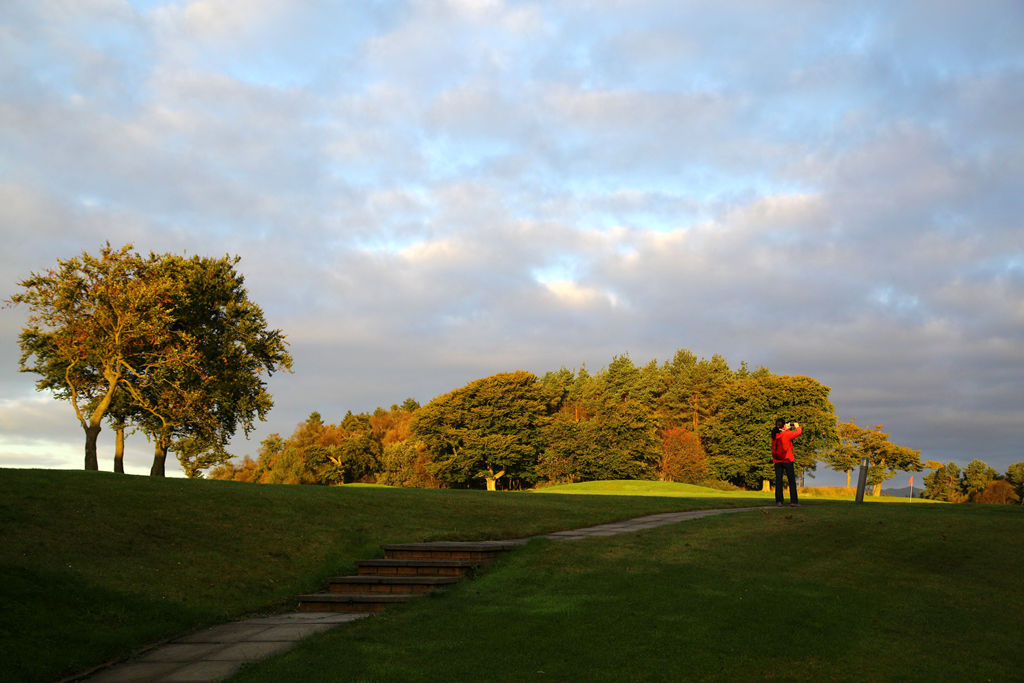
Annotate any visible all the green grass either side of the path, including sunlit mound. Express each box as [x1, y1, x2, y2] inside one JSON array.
[[0, 470, 1024, 681]]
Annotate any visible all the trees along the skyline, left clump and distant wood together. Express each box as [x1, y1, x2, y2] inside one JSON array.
[[19, 244, 1003, 501]]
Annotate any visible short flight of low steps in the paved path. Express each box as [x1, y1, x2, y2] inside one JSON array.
[[298, 540, 526, 612]]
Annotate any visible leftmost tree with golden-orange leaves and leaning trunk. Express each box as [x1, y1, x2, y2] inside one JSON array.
[[10, 244, 180, 470]]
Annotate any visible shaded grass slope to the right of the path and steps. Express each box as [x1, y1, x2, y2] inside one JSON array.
[[232, 497, 1024, 683]]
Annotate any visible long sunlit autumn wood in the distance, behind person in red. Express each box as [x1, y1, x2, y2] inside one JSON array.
[[211, 349, 921, 489]]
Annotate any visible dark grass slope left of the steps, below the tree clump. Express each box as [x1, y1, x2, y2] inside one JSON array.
[[0, 469, 750, 681]]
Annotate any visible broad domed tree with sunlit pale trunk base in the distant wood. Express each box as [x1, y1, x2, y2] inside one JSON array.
[[413, 371, 549, 490]]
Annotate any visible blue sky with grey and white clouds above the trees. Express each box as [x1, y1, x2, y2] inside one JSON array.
[[0, 0, 1024, 485]]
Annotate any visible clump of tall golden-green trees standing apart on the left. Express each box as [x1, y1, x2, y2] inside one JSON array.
[[7, 243, 292, 476]]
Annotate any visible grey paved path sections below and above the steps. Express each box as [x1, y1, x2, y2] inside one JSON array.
[[83, 506, 764, 683]]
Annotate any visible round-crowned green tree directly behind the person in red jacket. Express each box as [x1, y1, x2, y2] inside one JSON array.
[[700, 372, 838, 488]]
